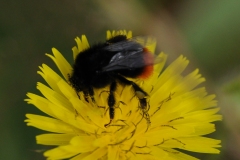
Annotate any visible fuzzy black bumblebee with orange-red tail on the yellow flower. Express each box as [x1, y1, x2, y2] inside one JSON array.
[[69, 35, 157, 127]]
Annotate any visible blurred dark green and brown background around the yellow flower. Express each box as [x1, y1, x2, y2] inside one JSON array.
[[0, 0, 240, 160]]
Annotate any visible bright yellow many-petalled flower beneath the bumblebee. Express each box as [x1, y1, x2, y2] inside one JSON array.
[[25, 31, 222, 160]]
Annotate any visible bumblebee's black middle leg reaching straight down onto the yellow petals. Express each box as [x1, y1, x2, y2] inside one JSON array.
[[104, 81, 117, 127]]
